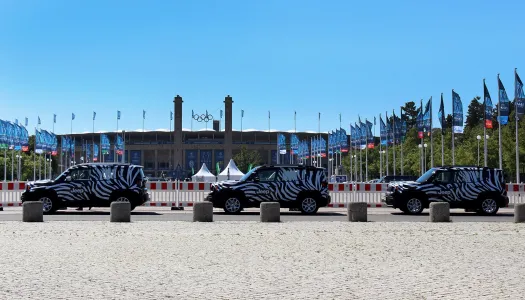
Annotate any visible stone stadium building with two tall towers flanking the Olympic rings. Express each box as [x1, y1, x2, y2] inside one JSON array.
[[63, 95, 327, 178]]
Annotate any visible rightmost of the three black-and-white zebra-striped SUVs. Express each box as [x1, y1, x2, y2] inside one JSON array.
[[385, 166, 509, 215]]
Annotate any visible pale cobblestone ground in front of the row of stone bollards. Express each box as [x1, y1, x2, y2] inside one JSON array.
[[0, 221, 525, 300]]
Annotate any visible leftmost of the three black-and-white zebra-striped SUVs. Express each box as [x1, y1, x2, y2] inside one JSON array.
[[22, 163, 149, 213]]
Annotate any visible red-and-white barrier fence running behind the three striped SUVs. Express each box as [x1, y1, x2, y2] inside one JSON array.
[[0, 181, 525, 208]]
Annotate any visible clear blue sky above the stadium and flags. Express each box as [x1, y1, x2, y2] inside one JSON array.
[[0, 0, 525, 133]]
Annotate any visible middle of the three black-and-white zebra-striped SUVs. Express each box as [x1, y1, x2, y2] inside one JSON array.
[[206, 165, 330, 214]]
